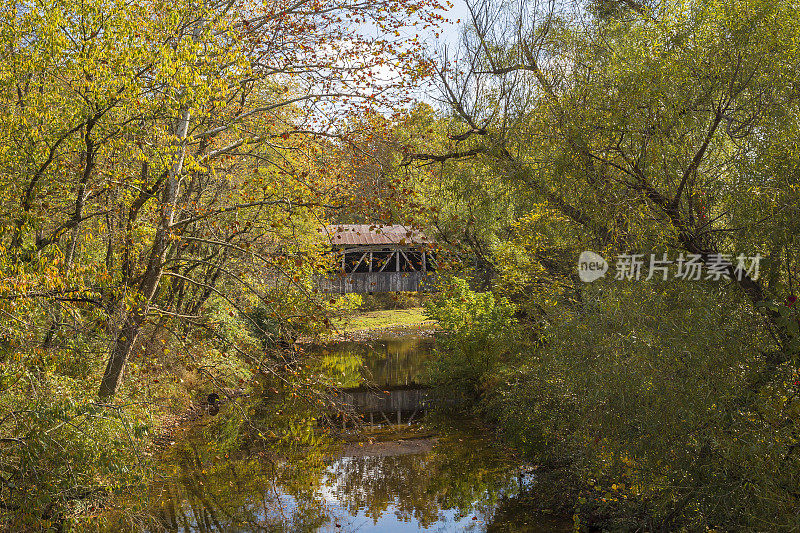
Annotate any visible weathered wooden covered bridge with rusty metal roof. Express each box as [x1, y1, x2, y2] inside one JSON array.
[[320, 224, 436, 294]]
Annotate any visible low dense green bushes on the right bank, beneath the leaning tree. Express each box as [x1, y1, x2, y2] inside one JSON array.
[[431, 282, 800, 531]]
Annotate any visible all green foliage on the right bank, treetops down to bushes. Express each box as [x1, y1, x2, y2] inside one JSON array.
[[409, 0, 800, 531]]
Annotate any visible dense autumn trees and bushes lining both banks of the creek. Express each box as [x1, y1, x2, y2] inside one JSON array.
[[0, 0, 800, 531]]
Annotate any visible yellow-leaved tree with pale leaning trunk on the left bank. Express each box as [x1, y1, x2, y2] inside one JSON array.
[[2, 0, 439, 399]]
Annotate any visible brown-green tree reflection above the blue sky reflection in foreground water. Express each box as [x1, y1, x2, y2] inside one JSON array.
[[330, 438, 517, 527]]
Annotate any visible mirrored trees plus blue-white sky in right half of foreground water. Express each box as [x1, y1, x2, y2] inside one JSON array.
[[328, 431, 519, 531]]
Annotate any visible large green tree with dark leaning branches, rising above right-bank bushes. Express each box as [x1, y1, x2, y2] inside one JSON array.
[[416, 2, 798, 354]]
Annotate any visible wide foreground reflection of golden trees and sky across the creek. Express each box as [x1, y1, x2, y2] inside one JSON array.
[[106, 429, 519, 532]]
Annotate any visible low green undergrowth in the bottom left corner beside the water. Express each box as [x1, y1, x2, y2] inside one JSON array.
[[0, 365, 153, 531]]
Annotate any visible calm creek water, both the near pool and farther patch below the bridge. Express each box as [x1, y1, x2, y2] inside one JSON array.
[[97, 332, 569, 533]]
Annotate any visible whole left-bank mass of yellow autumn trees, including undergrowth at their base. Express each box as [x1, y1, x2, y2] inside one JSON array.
[[0, 0, 441, 517]]
